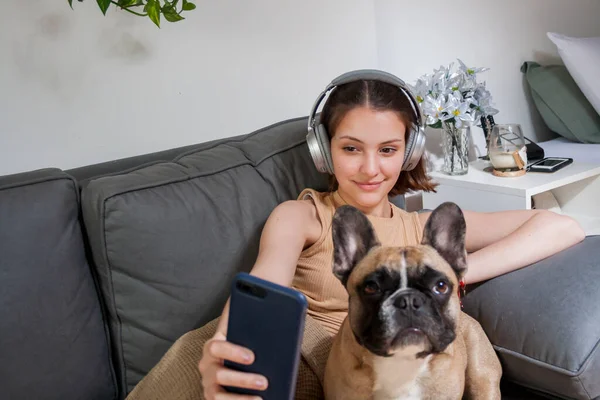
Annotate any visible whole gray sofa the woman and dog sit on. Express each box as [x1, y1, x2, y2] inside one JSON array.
[[0, 118, 600, 400]]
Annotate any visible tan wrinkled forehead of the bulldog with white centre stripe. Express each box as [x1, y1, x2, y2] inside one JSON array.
[[348, 246, 457, 289]]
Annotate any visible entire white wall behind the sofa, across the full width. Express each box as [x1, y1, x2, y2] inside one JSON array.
[[0, 0, 600, 175]]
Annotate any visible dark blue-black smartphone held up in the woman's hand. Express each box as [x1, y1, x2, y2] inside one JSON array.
[[225, 272, 308, 400]]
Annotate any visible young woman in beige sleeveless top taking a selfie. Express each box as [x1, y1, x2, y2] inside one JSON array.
[[137, 70, 584, 399]]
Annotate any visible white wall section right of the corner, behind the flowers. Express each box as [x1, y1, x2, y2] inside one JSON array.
[[374, 0, 600, 159]]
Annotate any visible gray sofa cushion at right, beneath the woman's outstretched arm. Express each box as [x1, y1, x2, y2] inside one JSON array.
[[464, 236, 600, 400]]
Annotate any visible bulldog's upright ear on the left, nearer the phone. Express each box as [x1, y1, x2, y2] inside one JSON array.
[[331, 205, 379, 286]]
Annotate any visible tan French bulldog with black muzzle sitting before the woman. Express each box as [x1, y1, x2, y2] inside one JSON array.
[[324, 203, 502, 400]]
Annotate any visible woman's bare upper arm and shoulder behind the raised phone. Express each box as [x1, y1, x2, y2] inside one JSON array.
[[217, 200, 321, 335]]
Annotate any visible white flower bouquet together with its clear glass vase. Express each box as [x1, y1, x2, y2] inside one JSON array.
[[411, 60, 498, 175]]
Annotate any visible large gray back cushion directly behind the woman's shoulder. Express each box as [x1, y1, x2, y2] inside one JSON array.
[[82, 118, 327, 390]]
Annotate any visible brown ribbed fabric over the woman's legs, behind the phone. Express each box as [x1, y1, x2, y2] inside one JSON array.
[[127, 316, 333, 400]]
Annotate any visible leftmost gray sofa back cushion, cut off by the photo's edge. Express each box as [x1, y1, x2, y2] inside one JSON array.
[[0, 169, 117, 400]]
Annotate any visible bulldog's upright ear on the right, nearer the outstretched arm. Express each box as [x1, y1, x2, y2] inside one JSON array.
[[422, 202, 467, 280]]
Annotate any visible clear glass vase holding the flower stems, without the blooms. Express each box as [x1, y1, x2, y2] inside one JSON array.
[[442, 122, 471, 175]]
